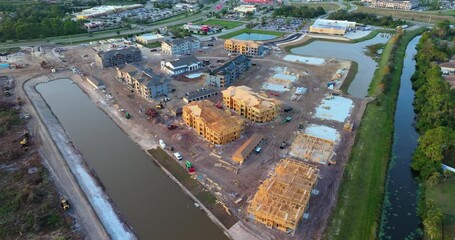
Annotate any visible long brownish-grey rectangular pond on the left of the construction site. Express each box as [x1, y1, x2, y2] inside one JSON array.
[[36, 79, 227, 240]]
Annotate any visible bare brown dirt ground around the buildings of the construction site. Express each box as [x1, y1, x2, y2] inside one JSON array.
[[7, 41, 365, 239]]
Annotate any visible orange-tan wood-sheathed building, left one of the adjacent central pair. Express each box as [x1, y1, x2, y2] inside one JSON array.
[[182, 100, 245, 144]]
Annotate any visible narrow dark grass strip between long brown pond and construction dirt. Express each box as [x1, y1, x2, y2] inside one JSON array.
[[148, 148, 237, 228]]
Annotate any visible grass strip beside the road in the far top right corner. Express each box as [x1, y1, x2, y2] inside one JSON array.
[[356, 6, 455, 23]]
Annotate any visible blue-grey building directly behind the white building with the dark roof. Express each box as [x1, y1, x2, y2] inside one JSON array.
[[161, 36, 201, 55]]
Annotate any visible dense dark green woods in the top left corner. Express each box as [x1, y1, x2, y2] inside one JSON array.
[[0, 3, 86, 41]]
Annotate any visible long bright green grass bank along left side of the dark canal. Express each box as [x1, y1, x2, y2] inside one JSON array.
[[324, 29, 423, 240]]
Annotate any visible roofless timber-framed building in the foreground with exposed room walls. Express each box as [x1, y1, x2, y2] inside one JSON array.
[[247, 158, 319, 232]]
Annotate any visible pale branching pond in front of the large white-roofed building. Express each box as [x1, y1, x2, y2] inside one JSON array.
[[291, 34, 390, 98]]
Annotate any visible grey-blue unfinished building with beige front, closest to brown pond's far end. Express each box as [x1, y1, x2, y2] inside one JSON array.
[[116, 64, 171, 99]]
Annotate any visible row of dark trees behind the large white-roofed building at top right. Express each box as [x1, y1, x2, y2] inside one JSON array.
[[328, 10, 406, 28]]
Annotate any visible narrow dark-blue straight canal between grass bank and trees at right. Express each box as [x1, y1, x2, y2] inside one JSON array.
[[380, 36, 421, 240]]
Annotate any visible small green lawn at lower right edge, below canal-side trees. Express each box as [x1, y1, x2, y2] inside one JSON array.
[[426, 175, 455, 239]]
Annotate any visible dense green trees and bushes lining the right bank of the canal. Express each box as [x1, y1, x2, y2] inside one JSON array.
[[411, 22, 455, 239]]
